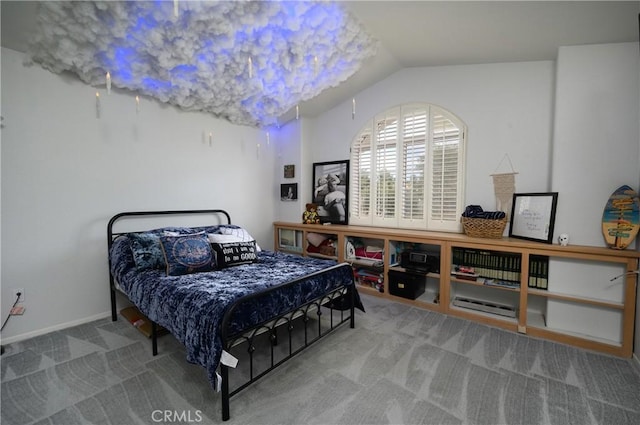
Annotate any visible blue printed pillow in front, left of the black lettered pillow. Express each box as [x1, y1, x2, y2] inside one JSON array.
[[160, 232, 216, 276]]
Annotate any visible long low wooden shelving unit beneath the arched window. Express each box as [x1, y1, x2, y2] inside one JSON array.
[[274, 222, 640, 357]]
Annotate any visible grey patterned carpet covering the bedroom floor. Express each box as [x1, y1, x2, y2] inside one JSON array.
[[1, 295, 640, 425]]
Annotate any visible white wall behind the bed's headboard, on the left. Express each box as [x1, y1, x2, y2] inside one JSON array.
[[0, 48, 279, 342]]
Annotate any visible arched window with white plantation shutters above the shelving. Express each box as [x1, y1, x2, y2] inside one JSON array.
[[349, 104, 467, 232]]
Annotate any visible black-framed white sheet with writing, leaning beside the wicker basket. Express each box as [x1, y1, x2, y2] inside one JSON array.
[[509, 192, 558, 243]]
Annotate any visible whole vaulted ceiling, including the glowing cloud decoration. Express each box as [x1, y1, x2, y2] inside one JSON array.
[[0, 0, 640, 126]]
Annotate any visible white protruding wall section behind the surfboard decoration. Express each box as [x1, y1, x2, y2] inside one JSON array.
[[552, 43, 640, 246]]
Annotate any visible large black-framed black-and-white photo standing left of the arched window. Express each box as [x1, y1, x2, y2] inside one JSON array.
[[311, 161, 349, 224]]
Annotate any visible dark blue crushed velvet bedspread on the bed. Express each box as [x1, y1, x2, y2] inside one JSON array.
[[110, 236, 355, 387]]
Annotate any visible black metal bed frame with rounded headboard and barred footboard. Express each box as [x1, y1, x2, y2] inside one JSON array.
[[107, 209, 356, 421]]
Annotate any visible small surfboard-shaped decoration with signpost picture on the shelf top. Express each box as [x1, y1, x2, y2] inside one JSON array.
[[602, 185, 640, 249]]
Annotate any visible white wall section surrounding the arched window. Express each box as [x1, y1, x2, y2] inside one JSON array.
[[309, 61, 555, 210]]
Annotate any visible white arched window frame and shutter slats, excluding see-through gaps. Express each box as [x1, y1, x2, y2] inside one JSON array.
[[349, 103, 467, 232]]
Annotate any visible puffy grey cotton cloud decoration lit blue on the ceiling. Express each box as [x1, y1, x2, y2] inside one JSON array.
[[28, 1, 377, 127]]
